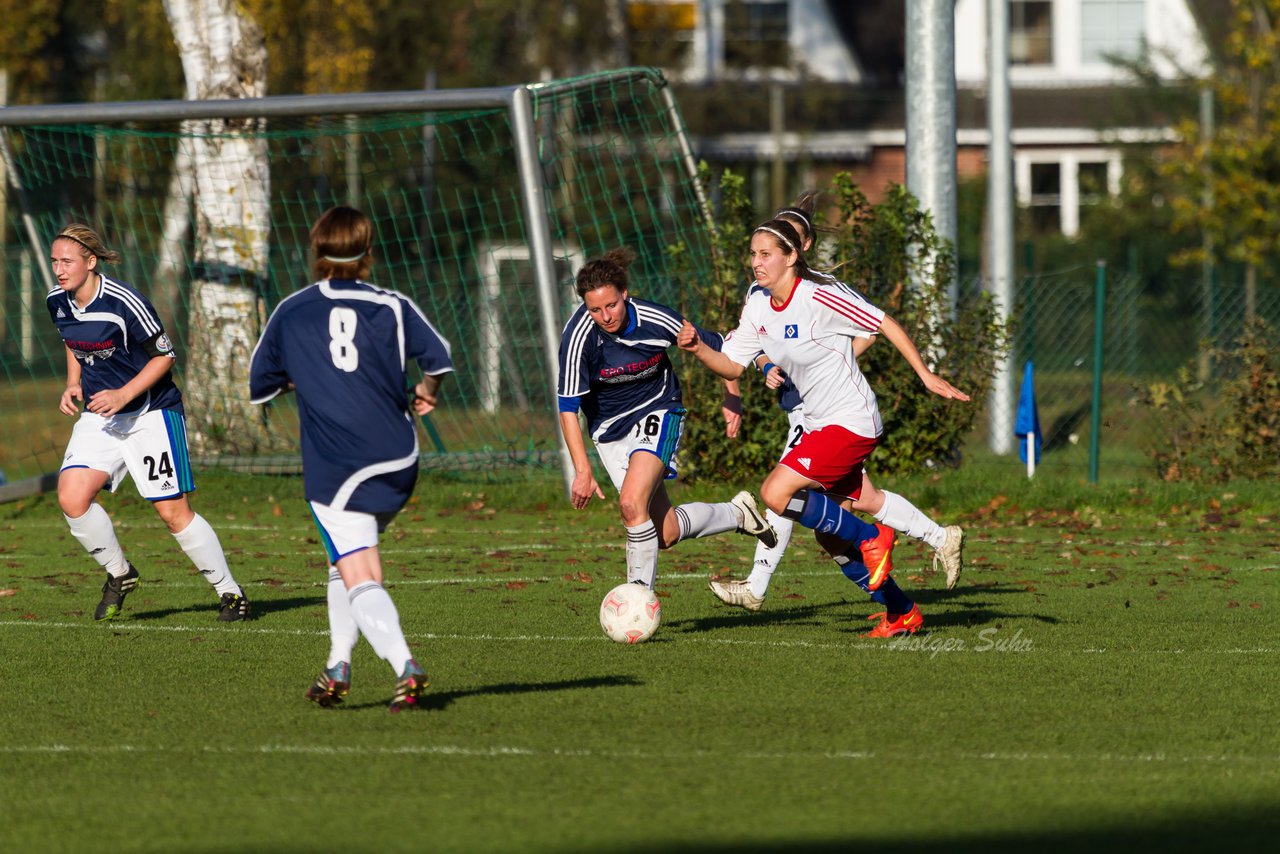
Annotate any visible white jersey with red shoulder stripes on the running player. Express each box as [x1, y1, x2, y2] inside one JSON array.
[[722, 279, 884, 438]]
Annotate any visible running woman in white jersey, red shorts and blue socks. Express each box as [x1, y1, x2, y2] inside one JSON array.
[[678, 219, 969, 636]]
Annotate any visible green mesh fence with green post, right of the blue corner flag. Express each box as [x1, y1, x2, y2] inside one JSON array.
[[970, 264, 1280, 478]]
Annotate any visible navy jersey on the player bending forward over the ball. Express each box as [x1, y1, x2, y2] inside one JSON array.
[[556, 297, 724, 442]]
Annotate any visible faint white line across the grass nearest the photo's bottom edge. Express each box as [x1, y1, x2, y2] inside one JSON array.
[[0, 742, 1280, 766]]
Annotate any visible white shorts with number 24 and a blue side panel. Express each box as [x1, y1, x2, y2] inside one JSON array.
[[61, 410, 196, 501]]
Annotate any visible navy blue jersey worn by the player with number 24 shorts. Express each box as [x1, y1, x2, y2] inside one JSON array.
[[45, 275, 182, 415]]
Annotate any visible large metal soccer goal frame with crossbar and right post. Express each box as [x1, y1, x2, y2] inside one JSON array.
[[0, 68, 712, 489]]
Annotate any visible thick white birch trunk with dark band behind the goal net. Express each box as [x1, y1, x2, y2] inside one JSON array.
[[164, 0, 270, 455]]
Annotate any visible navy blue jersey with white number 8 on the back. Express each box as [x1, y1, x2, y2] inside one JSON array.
[[250, 279, 453, 513]]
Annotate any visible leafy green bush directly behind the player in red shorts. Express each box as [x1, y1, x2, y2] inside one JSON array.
[[672, 168, 1009, 480]]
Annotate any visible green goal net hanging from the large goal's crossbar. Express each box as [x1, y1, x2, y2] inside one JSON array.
[[0, 69, 710, 481]]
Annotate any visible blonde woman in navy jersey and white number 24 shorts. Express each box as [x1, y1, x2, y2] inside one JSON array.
[[45, 224, 250, 621]]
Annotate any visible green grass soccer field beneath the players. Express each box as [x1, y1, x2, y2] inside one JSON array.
[[0, 466, 1280, 851]]
